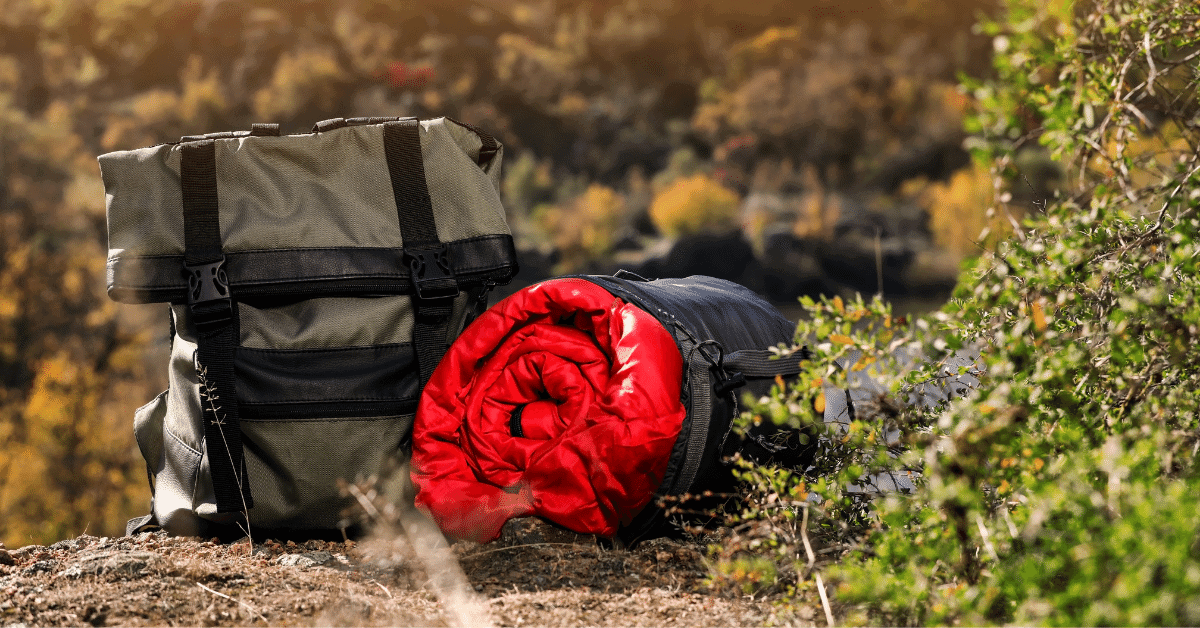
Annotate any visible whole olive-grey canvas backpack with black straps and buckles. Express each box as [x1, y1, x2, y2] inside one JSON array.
[[100, 118, 517, 536]]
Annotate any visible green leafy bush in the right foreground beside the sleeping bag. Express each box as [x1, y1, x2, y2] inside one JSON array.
[[724, 0, 1200, 626]]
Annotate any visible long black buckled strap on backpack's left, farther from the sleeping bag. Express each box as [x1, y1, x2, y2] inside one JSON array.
[[180, 139, 254, 513]]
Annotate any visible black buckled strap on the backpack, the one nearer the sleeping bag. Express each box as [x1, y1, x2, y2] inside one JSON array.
[[383, 119, 458, 389]]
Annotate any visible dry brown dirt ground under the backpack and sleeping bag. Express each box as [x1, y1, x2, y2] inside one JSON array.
[[0, 520, 824, 627]]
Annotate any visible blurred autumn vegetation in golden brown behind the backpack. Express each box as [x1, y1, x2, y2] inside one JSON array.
[[0, 0, 1012, 546]]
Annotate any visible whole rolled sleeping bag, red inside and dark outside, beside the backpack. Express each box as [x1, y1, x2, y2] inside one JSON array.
[[412, 273, 810, 542]]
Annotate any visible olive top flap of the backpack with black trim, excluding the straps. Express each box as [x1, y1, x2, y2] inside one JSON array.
[[100, 118, 516, 303]]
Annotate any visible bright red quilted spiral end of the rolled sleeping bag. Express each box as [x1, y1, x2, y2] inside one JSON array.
[[413, 279, 685, 542]]
